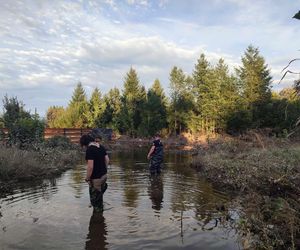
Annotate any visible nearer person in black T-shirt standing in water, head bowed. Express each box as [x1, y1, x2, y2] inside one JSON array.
[[80, 134, 109, 212]]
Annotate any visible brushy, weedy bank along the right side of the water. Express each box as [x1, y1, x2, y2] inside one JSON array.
[[192, 137, 300, 249]]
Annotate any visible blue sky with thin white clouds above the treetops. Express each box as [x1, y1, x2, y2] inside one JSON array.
[[0, 0, 300, 117]]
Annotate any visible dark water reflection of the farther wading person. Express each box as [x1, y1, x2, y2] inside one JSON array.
[[148, 175, 164, 211]]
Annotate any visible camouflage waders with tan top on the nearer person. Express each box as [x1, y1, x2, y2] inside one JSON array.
[[89, 176, 107, 212]]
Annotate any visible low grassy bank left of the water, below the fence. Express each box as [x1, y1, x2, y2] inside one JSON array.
[[0, 137, 81, 192]]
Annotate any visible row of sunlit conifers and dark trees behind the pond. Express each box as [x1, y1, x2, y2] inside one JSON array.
[[47, 45, 300, 137]]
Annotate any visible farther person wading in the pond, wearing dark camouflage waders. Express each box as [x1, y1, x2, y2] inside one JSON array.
[[147, 134, 164, 174]]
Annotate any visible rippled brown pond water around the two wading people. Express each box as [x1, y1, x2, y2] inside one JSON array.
[[0, 149, 239, 250]]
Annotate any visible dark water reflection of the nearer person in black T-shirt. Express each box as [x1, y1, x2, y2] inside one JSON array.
[[85, 213, 108, 250]]
